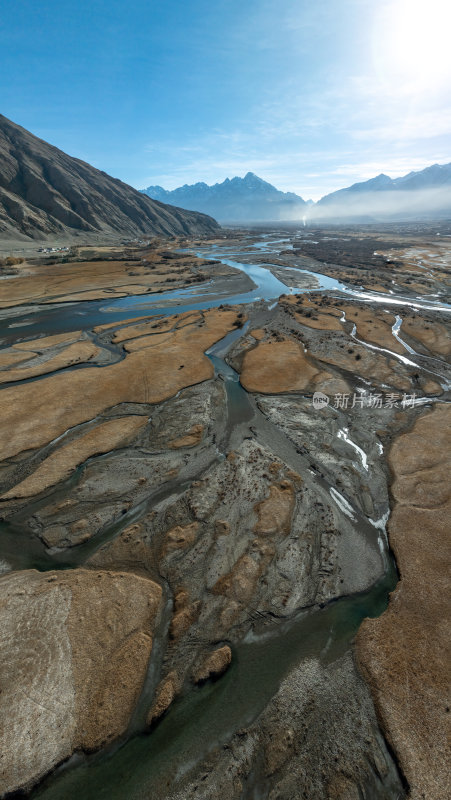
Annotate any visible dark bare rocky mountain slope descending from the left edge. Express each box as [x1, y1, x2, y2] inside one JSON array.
[[0, 115, 218, 240]]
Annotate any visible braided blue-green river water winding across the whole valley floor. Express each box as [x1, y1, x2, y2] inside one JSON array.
[[0, 230, 444, 800]]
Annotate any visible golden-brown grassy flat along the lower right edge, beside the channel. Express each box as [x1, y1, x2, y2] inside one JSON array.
[[357, 405, 451, 800]]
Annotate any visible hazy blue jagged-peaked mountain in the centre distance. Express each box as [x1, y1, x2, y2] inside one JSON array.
[[142, 172, 308, 222]]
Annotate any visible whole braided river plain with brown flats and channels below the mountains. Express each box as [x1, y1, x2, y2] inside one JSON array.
[[0, 222, 451, 800]]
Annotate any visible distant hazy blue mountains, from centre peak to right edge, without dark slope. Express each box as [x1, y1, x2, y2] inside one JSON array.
[[141, 164, 451, 223]]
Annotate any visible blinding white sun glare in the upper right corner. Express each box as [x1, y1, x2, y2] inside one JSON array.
[[373, 0, 451, 93]]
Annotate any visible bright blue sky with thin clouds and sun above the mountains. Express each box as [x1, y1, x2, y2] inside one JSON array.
[[0, 0, 451, 199]]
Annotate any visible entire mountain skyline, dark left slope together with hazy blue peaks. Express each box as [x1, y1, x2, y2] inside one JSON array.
[[0, 115, 451, 241]]
